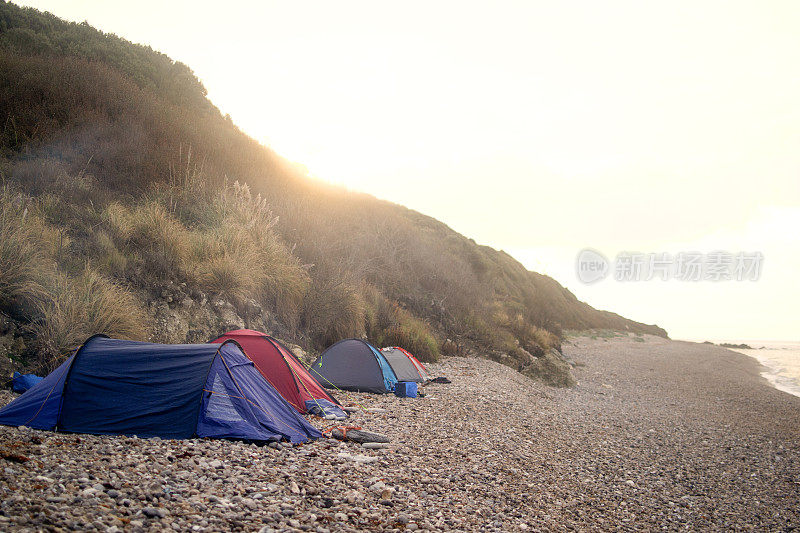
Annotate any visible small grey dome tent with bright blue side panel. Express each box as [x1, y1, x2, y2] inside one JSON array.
[[309, 339, 397, 393]]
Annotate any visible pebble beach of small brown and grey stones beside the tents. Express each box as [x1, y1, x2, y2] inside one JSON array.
[[0, 337, 800, 532]]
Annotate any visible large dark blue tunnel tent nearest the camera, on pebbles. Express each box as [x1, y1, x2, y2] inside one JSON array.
[[0, 335, 321, 442]]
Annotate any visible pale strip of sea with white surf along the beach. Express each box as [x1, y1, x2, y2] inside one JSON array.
[[729, 341, 800, 396]]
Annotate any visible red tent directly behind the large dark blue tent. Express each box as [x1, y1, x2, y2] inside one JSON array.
[[211, 329, 347, 418]]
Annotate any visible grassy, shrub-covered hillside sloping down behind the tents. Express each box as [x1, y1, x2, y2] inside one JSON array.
[[0, 2, 666, 380]]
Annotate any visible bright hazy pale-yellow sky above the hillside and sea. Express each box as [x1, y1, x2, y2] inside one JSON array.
[[17, 0, 800, 340]]
